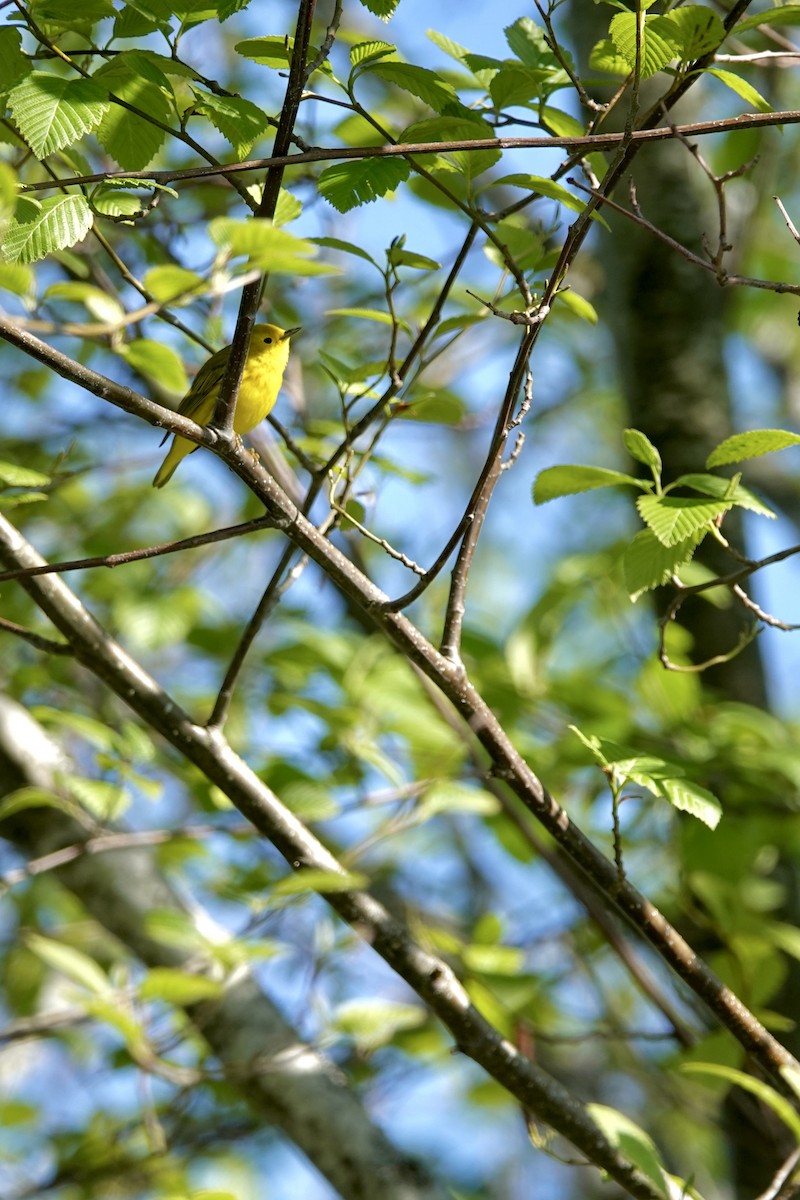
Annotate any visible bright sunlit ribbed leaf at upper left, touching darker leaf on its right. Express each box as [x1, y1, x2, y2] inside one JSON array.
[[8, 71, 109, 158]]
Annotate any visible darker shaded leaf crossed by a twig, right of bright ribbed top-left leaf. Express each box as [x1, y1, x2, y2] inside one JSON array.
[[92, 50, 173, 170]]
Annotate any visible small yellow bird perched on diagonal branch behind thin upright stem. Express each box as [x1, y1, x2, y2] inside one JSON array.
[[152, 325, 300, 487]]
